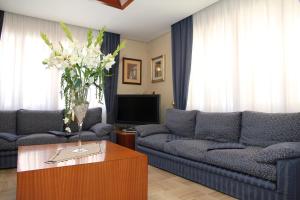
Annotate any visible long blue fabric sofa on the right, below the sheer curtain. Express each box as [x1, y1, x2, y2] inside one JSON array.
[[136, 109, 300, 200]]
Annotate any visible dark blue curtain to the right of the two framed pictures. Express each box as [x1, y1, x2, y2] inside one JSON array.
[[172, 16, 193, 110]]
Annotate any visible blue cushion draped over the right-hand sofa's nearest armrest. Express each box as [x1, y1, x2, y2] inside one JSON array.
[[255, 142, 300, 164]]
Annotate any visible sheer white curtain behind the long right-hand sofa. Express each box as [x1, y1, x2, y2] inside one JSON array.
[[188, 0, 300, 112]]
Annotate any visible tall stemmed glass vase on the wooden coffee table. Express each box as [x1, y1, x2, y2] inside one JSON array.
[[73, 102, 89, 153]]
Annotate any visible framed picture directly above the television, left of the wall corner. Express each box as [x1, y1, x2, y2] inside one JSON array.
[[122, 58, 142, 85]]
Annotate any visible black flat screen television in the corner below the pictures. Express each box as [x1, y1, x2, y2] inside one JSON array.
[[116, 95, 160, 124]]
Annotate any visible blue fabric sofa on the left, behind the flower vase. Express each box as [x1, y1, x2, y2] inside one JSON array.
[[0, 108, 113, 169]]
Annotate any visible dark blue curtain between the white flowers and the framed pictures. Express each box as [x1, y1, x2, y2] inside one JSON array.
[[101, 32, 120, 124]]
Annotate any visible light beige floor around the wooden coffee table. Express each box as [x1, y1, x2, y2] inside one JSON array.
[[0, 166, 233, 200]]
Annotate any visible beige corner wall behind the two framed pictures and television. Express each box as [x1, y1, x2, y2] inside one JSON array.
[[118, 33, 173, 122]]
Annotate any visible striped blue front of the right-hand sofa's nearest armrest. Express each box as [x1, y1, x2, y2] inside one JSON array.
[[277, 158, 300, 200]]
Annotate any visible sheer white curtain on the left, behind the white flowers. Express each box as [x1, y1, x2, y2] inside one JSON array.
[[0, 12, 106, 120]]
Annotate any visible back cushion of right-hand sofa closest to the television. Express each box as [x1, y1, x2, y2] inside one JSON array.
[[165, 109, 197, 137]]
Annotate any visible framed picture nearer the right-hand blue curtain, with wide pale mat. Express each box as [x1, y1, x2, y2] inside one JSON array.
[[151, 55, 165, 83]]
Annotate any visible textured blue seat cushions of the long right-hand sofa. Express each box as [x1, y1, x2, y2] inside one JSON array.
[[164, 140, 276, 181]]
